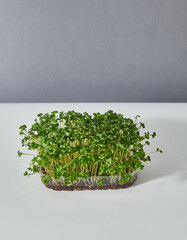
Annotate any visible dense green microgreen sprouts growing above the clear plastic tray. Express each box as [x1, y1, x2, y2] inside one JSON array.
[[18, 110, 162, 185]]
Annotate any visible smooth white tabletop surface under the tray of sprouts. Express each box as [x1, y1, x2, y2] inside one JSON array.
[[0, 103, 187, 240]]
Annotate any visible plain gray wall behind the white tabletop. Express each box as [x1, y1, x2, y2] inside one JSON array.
[[0, 0, 187, 102]]
